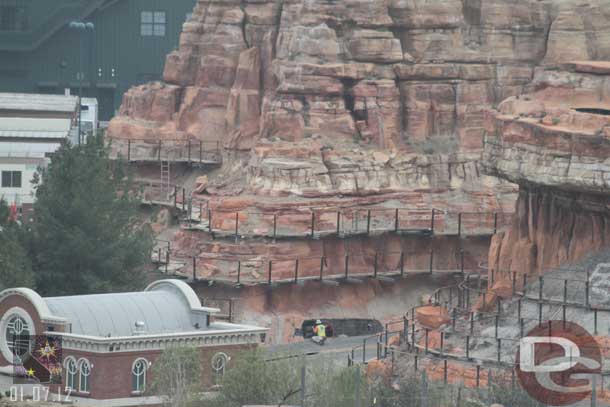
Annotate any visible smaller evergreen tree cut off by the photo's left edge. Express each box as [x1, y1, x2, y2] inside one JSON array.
[[0, 200, 34, 290]]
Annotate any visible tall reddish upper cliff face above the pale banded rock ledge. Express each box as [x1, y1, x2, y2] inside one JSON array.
[[109, 0, 610, 155]]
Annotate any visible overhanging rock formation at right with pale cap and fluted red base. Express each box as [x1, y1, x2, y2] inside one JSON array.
[[482, 61, 610, 273]]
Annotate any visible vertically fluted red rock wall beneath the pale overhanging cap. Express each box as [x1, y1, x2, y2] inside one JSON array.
[[489, 189, 610, 281]]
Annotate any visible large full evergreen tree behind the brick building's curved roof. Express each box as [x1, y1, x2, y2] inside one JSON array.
[[30, 136, 152, 295]]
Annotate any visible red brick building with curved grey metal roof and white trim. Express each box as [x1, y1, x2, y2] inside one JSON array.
[[0, 280, 266, 406]]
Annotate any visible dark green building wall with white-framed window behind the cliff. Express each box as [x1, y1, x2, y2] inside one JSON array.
[[0, 0, 196, 120]]
